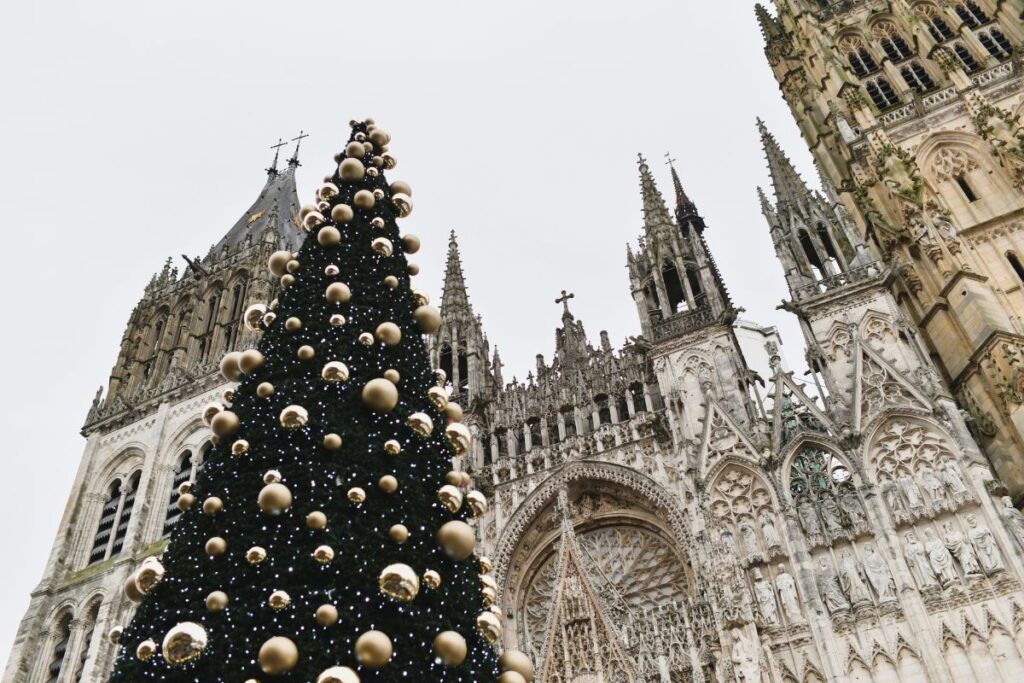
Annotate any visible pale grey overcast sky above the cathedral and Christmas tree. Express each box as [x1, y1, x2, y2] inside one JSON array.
[[0, 0, 816, 661]]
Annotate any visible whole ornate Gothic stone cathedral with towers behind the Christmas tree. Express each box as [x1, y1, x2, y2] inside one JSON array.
[[3, 0, 1024, 683]]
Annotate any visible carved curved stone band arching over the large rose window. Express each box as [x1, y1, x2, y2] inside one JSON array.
[[494, 461, 693, 588]]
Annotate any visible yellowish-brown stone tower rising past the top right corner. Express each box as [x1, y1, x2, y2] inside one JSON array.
[[757, 0, 1024, 501]]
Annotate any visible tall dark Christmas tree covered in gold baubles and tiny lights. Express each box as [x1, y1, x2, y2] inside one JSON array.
[[111, 120, 532, 683]]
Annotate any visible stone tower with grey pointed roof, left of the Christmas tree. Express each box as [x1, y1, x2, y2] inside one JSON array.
[[3, 150, 301, 683]]
